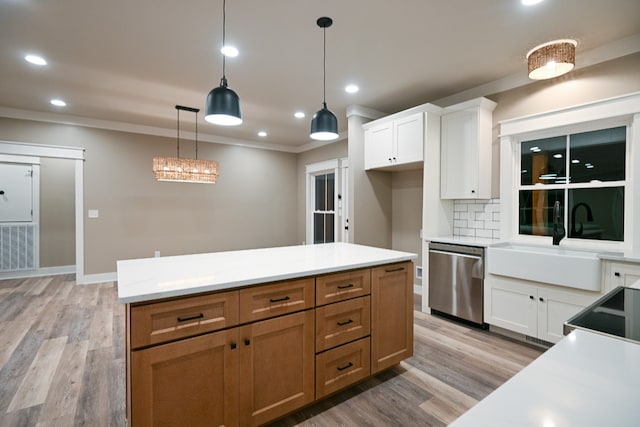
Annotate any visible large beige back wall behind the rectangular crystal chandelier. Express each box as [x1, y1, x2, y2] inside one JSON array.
[[0, 119, 297, 274]]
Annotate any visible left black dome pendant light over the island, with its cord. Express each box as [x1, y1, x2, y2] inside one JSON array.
[[204, 0, 242, 126]]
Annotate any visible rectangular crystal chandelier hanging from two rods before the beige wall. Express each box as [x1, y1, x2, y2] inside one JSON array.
[[153, 105, 219, 184]]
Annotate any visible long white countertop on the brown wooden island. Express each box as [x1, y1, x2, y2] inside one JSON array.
[[117, 243, 417, 303]]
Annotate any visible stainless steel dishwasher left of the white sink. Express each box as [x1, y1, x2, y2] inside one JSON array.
[[429, 242, 484, 325]]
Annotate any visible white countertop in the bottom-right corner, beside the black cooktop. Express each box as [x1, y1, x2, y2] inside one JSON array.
[[450, 330, 640, 427]]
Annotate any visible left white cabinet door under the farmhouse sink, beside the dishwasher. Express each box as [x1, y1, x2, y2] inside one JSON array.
[[484, 278, 538, 337]]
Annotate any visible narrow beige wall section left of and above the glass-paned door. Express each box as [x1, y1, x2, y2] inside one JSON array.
[[296, 139, 347, 243]]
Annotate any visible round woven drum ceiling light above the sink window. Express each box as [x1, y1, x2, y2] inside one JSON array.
[[527, 39, 578, 80]]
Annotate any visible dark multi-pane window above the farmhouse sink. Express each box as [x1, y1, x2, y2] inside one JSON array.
[[518, 126, 627, 242]]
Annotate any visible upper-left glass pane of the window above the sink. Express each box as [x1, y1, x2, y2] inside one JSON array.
[[520, 136, 567, 185]]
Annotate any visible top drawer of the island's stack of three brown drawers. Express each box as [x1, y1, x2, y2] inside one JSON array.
[[316, 268, 371, 305]]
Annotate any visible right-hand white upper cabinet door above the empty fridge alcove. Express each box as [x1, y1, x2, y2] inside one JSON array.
[[392, 113, 424, 164]]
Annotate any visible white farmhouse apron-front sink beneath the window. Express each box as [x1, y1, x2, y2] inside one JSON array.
[[487, 243, 602, 291]]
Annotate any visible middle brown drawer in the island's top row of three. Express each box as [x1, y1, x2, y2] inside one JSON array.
[[240, 277, 315, 323]]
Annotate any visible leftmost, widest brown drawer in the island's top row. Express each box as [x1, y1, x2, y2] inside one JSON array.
[[130, 291, 238, 349]]
